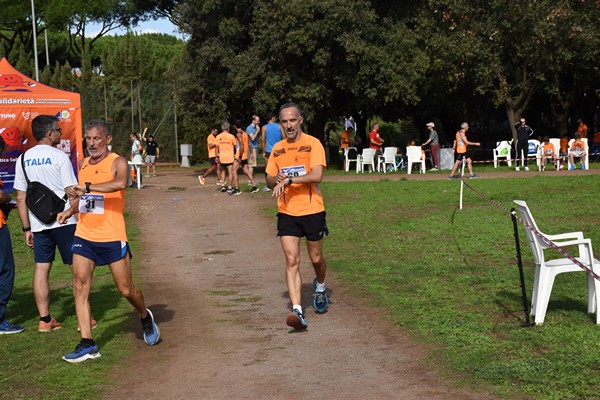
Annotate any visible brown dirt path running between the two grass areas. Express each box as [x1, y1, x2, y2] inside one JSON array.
[[105, 169, 572, 399]]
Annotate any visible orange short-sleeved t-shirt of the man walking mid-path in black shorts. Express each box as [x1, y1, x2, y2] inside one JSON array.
[[266, 133, 327, 217]]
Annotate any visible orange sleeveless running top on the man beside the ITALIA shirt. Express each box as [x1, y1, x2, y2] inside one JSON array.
[[75, 153, 127, 242]]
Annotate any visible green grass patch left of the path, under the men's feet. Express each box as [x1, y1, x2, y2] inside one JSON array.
[[0, 211, 138, 399]]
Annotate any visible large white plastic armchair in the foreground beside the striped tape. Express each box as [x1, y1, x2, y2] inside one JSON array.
[[515, 200, 600, 324]]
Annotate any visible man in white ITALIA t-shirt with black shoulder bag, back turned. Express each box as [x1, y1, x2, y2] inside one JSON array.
[[14, 115, 77, 332]]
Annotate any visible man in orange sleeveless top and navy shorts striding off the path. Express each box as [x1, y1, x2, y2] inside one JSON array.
[[57, 120, 160, 363]]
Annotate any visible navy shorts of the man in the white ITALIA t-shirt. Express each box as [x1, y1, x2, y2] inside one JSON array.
[[33, 224, 77, 265]]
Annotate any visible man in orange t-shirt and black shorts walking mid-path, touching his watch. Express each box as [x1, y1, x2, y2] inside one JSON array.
[[266, 103, 329, 330]]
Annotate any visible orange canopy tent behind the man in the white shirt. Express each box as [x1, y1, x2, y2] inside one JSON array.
[[0, 58, 83, 191]]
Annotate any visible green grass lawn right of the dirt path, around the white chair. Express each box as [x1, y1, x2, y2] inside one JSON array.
[[322, 175, 600, 399]]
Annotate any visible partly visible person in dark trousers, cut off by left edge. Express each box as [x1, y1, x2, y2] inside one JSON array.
[[0, 137, 25, 335]]
